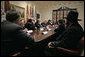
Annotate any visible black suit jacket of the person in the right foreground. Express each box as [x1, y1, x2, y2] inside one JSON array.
[[52, 24, 84, 49]]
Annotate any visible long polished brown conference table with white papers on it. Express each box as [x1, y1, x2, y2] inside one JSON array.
[[30, 26, 56, 42]]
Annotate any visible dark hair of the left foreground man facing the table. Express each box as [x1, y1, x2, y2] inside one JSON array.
[[6, 10, 20, 22]]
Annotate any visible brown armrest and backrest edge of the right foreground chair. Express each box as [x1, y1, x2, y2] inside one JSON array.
[[57, 37, 84, 56]]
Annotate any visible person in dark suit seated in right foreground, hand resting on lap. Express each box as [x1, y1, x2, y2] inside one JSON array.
[[48, 11, 84, 53]]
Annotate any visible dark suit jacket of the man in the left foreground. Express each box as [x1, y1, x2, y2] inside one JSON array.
[[1, 21, 34, 56]]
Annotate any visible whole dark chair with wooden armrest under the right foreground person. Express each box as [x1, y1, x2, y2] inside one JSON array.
[[45, 37, 84, 56]]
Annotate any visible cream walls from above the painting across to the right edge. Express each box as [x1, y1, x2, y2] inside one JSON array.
[[1, 1, 84, 28]]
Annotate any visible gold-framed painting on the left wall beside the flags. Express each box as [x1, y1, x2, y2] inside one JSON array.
[[11, 4, 25, 19]]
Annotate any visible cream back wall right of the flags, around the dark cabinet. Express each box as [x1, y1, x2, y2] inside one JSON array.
[[38, 1, 84, 29]]
